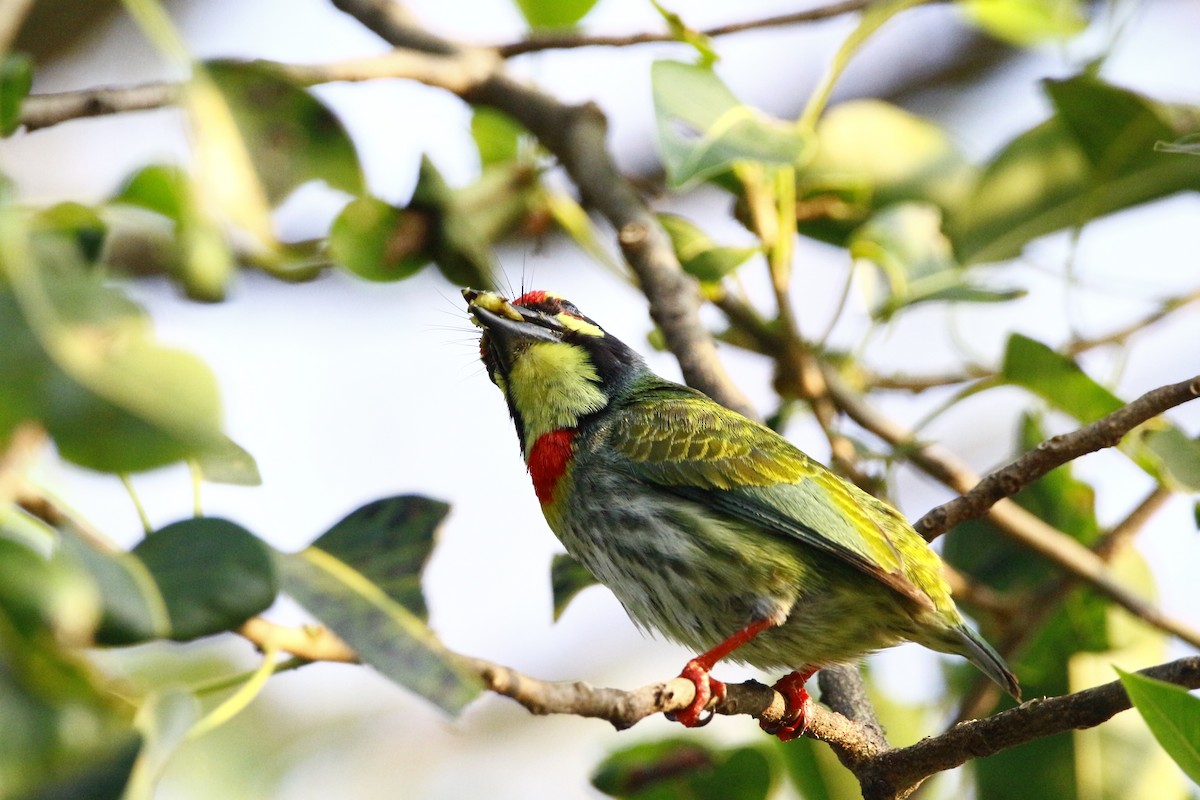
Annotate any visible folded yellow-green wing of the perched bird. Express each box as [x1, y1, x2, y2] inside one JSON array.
[[606, 387, 934, 608]]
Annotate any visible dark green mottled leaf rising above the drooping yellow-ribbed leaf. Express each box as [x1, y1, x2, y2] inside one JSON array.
[[313, 494, 450, 621]]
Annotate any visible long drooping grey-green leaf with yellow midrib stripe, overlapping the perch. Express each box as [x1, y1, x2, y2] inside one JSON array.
[[275, 547, 480, 714]]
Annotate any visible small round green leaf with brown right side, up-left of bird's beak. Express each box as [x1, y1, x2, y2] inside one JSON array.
[[329, 197, 432, 281]]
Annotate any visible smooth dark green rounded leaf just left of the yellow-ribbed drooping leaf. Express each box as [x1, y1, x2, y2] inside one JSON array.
[[132, 517, 278, 642]]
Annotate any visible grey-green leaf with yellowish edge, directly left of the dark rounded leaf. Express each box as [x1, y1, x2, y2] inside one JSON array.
[[55, 527, 170, 645]]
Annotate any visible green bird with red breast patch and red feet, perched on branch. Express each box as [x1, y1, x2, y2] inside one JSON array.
[[462, 289, 1020, 741]]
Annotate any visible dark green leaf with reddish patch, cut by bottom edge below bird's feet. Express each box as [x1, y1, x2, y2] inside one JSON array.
[[592, 739, 773, 800]]
